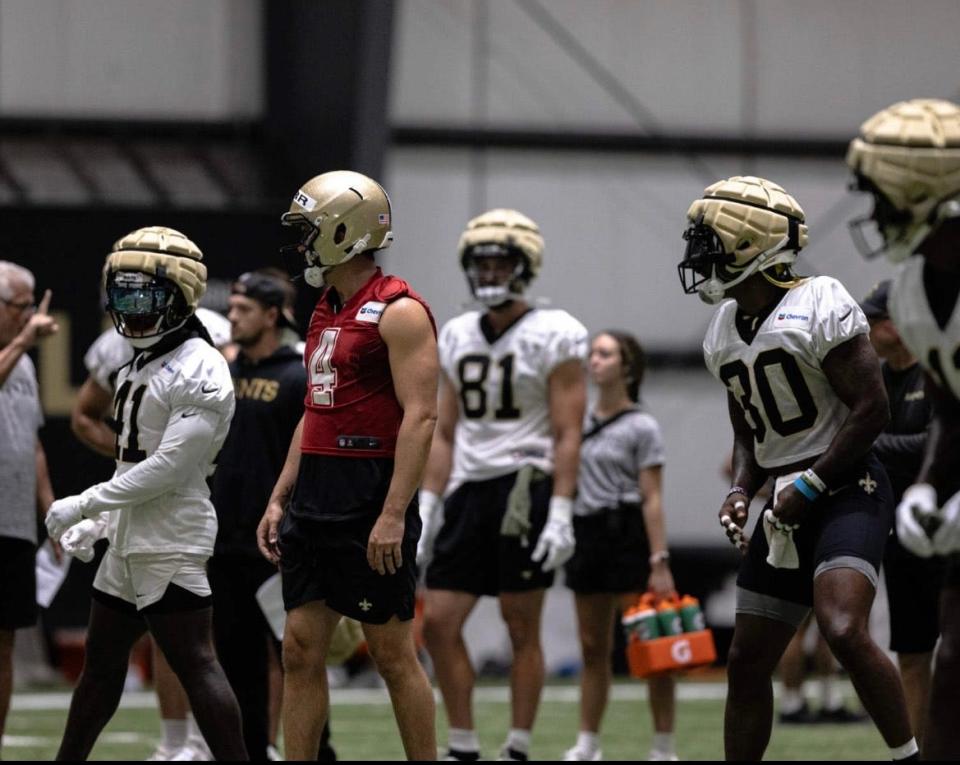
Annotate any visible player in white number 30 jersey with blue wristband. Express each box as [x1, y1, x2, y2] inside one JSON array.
[[679, 176, 917, 760]]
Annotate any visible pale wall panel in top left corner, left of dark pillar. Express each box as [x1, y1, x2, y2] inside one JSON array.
[[0, 0, 263, 120]]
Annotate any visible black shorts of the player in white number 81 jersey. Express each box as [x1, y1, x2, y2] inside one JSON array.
[[426, 466, 553, 595]]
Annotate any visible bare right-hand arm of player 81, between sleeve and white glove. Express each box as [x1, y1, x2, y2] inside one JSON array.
[[547, 359, 587, 497]]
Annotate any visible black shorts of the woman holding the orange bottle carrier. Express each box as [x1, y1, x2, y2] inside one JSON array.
[[566, 505, 650, 595]]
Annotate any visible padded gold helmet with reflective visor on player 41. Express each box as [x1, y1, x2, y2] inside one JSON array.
[[103, 226, 207, 348]]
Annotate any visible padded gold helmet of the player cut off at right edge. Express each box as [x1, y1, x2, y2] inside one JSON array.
[[847, 98, 960, 263]]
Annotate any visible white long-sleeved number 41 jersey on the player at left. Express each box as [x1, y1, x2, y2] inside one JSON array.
[[80, 337, 234, 555]]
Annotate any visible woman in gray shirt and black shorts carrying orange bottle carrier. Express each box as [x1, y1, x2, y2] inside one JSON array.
[[564, 330, 677, 760]]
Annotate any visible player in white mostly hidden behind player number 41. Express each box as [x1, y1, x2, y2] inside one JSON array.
[[68, 308, 230, 761]]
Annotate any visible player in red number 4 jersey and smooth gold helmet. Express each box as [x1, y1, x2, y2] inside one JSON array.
[[257, 171, 439, 760]]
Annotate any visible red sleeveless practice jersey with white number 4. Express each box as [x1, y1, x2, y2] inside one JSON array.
[[300, 268, 436, 457]]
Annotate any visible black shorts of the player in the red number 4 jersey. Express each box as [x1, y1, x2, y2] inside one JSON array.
[[278, 458, 421, 624]]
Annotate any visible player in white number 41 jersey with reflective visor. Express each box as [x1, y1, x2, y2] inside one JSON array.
[[47, 226, 246, 759]]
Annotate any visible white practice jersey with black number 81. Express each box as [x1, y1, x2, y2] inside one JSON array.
[[438, 308, 587, 491]]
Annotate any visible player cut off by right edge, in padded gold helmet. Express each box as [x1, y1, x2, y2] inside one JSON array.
[[847, 99, 960, 759]]
